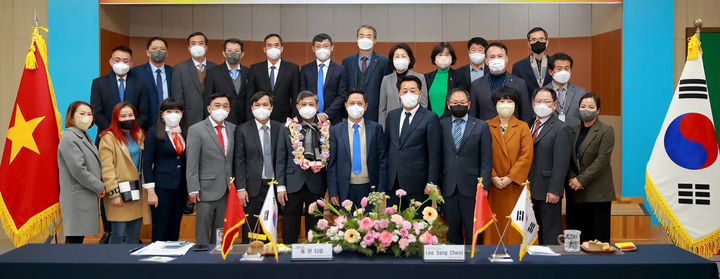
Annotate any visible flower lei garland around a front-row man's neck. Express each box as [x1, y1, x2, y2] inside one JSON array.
[[285, 117, 330, 170]]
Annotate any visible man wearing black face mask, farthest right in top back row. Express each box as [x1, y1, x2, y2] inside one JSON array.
[[513, 27, 552, 101]]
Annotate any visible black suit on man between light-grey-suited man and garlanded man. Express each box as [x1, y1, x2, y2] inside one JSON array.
[[233, 118, 283, 243]]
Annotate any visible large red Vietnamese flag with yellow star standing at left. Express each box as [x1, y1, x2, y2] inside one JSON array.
[[0, 27, 62, 247]]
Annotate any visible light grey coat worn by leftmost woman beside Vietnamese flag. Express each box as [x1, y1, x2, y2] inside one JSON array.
[[58, 127, 105, 236]]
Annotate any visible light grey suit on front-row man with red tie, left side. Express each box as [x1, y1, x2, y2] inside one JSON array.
[[186, 118, 235, 244]]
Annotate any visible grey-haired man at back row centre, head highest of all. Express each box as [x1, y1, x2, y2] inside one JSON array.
[[343, 25, 391, 121]]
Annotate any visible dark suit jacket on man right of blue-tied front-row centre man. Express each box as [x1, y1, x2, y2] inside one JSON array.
[[380, 107, 442, 194]]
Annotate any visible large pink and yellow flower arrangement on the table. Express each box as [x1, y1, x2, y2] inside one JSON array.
[[307, 188, 447, 257]]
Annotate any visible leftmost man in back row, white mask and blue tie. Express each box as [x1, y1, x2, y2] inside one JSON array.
[[90, 46, 148, 144]]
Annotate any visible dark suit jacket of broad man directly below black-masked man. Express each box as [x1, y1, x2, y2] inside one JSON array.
[[470, 73, 535, 121]]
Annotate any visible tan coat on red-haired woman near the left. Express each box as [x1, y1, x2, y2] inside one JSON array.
[[99, 133, 152, 224]]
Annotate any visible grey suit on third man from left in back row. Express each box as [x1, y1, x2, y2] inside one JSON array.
[[171, 58, 217, 125]]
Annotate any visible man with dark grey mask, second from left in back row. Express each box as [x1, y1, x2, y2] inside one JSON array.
[[130, 37, 172, 130]]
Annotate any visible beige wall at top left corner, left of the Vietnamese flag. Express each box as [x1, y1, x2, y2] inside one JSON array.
[[0, 0, 51, 241]]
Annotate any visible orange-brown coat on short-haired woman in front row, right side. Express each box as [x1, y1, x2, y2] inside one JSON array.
[[483, 116, 533, 245]]
